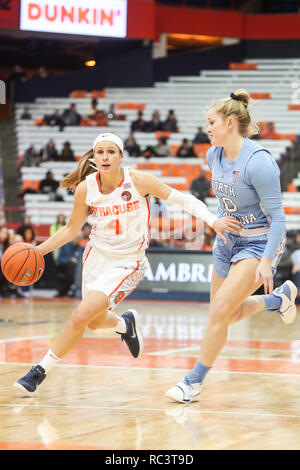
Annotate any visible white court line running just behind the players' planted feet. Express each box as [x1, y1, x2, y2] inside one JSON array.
[[0, 361, 300, 379]]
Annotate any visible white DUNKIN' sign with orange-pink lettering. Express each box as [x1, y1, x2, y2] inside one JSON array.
[[20, 0, 127, 38]]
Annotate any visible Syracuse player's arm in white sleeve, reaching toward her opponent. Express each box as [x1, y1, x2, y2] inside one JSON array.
[[132, 170, 242, 242]]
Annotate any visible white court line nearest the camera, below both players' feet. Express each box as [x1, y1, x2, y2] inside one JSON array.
[[0, 403, 300, 419]]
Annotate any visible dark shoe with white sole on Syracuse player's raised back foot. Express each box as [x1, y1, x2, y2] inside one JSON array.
[[117, 308, 144, 358]]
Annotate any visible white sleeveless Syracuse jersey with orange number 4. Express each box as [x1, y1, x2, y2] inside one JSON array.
[[85, 167, 150, 258]]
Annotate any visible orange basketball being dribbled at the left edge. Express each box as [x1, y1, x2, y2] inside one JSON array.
[[1, 243, 45, 286]]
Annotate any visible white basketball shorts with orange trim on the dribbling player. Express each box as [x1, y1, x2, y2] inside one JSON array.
[[82, 243, 149, 310]]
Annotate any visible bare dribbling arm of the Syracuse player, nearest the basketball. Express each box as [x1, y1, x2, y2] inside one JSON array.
[[38, 181, 89, 255]]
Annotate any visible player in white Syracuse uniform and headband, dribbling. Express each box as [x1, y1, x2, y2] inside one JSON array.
[[15, 133, 241, 395]]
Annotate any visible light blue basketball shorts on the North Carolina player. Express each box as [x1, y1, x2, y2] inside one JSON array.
[[213, 232, 286, 277]]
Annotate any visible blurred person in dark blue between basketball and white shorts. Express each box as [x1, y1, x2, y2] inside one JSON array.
[[55, 235, 83, 297]]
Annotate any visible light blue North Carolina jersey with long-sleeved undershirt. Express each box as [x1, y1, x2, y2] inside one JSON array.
[[206, 137, 285, 258]]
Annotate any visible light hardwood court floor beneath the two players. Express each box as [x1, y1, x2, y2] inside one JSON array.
[[0, 299, 300, 451]]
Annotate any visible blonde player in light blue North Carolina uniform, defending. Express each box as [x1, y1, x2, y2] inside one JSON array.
[[166, 90, 297, 403]]
